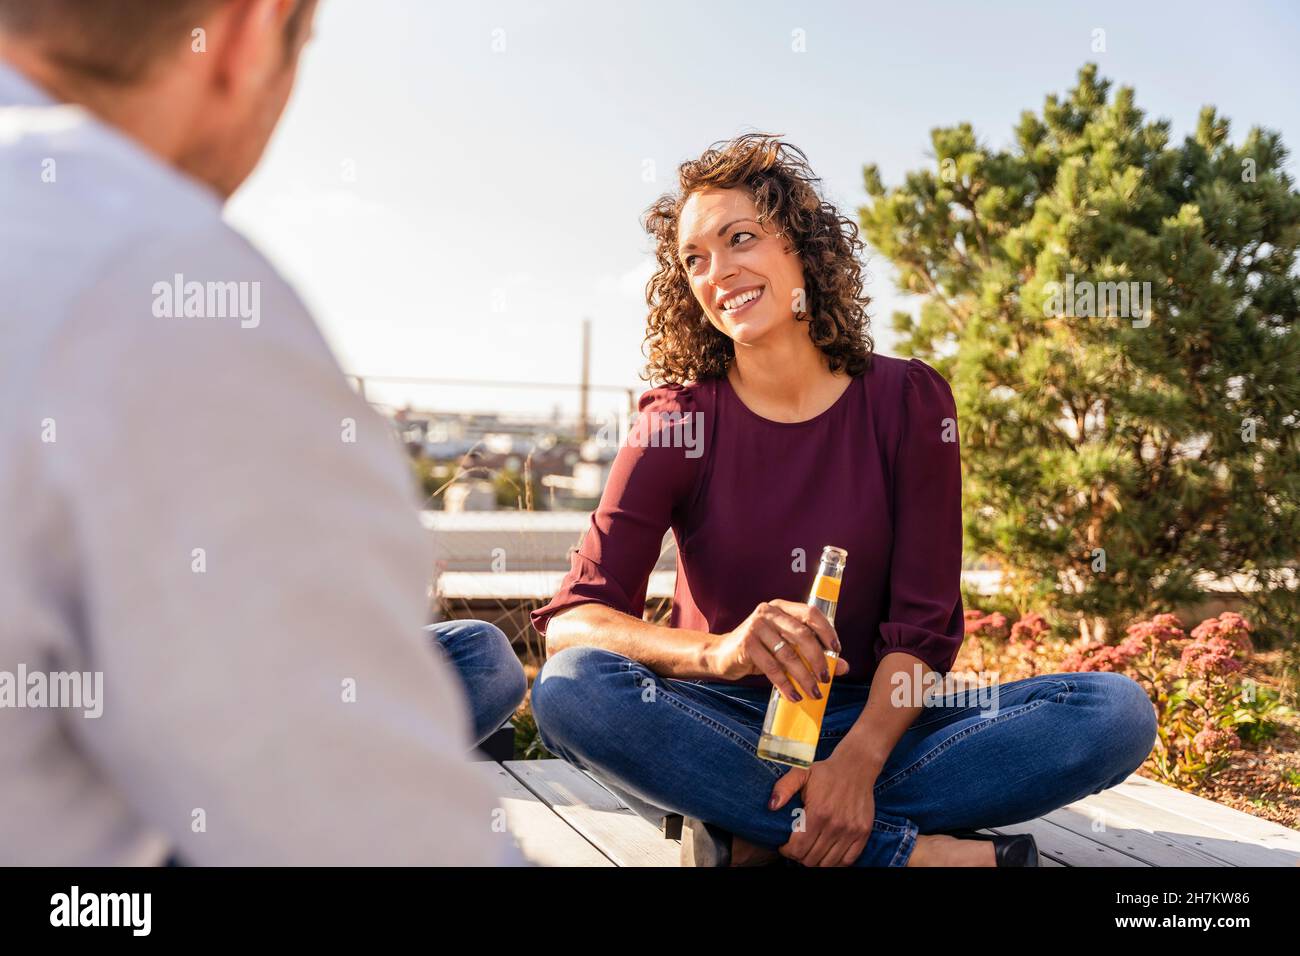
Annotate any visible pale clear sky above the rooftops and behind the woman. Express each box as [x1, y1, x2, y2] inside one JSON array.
[[229, 0, 1300, 412]]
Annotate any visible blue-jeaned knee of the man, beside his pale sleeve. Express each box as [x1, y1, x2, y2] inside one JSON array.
[[424, 620, 528, 745]]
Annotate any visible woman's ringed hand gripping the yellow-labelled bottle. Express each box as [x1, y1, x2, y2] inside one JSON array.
[[711, 598, 849, 701]]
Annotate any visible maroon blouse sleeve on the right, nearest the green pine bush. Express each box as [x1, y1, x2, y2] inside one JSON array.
[[876, 359, 965, 674]]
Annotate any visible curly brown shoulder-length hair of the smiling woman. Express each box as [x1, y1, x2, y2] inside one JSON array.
[[641, 133, 874, 384]]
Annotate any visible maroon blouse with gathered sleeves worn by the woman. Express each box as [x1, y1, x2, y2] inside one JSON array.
[[532, 354, 965, 687]]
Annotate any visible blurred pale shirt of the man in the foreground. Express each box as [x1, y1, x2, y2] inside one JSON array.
[[0, 59, 523, 865]]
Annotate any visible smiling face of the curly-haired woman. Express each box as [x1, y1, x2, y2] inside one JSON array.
[[677, 189, 803, 345]]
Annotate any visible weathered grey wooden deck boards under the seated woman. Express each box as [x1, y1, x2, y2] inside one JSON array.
[[478, 760, 1300, 866]]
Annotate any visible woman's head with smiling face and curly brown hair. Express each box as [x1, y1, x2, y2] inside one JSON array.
[[645, 133, 872, 382]]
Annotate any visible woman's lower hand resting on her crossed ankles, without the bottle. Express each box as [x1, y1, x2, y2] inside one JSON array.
[[768, 753, 876, 866]]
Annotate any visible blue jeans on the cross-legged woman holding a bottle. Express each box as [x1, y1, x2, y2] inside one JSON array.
[[532, 646, 1156, 866]]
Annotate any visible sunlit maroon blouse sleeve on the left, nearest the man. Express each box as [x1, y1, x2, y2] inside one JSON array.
[[529, 385, 703, 637]]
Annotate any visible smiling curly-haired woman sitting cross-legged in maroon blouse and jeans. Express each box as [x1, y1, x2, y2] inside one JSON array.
[[532, 134, 1156, 866]]
